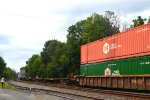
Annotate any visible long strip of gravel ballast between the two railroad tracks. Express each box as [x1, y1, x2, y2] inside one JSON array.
[[12, 82, 137, 100]]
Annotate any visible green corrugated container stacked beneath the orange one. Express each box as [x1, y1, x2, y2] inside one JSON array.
[[80, 56, 150, 76]]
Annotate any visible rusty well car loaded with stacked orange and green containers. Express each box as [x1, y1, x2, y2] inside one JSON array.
[[75, 24, 150, 90]]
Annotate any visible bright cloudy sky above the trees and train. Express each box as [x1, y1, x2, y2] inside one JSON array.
[[0, 0, 150, 72]]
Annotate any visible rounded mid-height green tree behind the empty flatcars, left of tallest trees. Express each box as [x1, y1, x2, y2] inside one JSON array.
[[41, 40, 66, 77]]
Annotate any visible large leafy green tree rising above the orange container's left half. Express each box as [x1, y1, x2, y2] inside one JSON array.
[[82, 11, 119, 44]]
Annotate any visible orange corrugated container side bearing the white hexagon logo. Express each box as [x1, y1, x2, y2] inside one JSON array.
[[81, 24, 150, 63]]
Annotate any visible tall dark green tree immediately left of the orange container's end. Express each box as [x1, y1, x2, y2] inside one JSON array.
[[66, 20, 85, 74]]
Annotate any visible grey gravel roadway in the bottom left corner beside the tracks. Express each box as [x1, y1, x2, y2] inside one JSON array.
[[0, 89, 62, 100]]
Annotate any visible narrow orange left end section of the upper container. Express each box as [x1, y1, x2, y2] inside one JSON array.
[[81, 44, 88, 64]]
